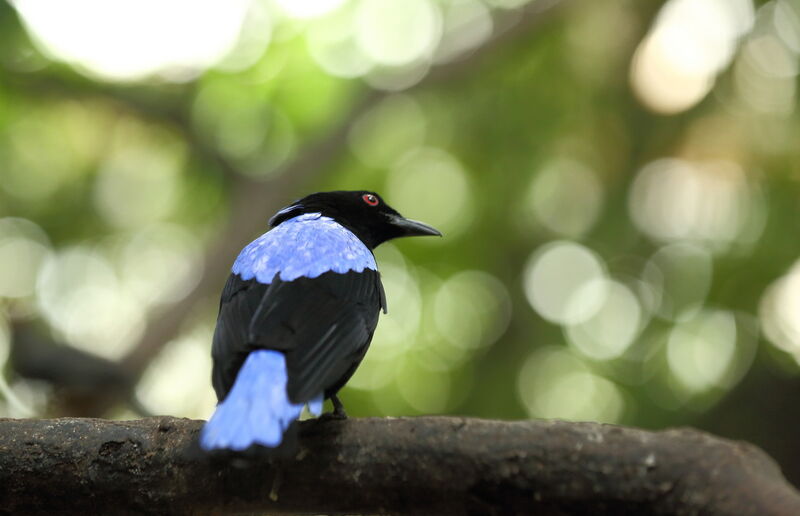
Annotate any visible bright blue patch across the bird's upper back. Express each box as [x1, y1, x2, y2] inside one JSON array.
[[231, 213, 378, 284]]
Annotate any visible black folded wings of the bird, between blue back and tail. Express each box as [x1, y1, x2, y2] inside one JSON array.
[[212, 269, 385, 402]]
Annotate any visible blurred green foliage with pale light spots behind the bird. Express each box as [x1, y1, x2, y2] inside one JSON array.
[[0, 0, 800, 482]]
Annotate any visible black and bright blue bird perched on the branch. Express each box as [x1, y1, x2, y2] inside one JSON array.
[[200, 190, 441, 452]]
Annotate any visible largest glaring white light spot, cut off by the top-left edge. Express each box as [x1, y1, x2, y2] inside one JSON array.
[[13, 0, 255, 80]]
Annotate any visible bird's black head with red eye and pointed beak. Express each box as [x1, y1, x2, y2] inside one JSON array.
[[269, 190, 442, 249]]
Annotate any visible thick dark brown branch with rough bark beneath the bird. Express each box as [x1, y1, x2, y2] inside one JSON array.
[[0, 417, 800, 516]]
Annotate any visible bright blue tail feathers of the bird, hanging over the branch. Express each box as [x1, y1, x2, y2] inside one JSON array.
[[200, 349, 322, 451]]
